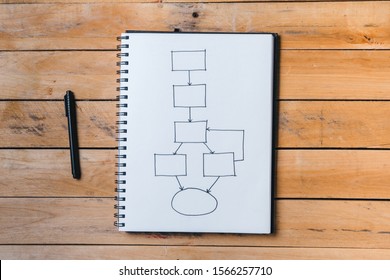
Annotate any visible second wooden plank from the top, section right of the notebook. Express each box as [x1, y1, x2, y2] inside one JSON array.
[[280, 50, 390, 100]]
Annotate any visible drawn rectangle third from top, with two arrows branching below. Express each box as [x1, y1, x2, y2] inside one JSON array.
[[174, 121, 207, 143]]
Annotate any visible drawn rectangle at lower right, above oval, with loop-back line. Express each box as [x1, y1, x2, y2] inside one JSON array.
[[203, 153, 236, 177]]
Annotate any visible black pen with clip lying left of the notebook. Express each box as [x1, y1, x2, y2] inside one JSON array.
[[64, 90, 81, 179]]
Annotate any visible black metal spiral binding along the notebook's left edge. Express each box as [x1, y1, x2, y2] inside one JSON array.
[[114, 36, 129, 227]]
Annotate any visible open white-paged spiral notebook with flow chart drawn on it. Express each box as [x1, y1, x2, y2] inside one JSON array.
[[115, 31, 279, 234]]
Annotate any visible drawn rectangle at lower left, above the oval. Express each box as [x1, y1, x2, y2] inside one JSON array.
[[154, 154, 187, 176]]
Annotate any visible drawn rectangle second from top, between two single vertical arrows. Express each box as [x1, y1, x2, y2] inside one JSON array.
[[173, 84, 206, 108]]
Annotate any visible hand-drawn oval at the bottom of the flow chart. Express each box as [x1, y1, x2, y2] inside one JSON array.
[[171, 188, 218, 216]]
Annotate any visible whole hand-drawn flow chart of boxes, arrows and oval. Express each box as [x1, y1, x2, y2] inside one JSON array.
[[154, 50, 245, 216]]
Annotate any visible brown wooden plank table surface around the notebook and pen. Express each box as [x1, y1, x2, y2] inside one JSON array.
[[0, 0, 390, 259]]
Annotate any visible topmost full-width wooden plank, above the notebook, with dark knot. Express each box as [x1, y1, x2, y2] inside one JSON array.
[[0, 1, 390, 50]]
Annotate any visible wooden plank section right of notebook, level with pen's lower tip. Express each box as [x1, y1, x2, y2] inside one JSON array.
[[276, 150, 390, 199]]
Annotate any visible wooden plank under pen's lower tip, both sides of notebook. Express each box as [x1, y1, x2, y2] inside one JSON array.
[[0, 149, 390, 199]]
